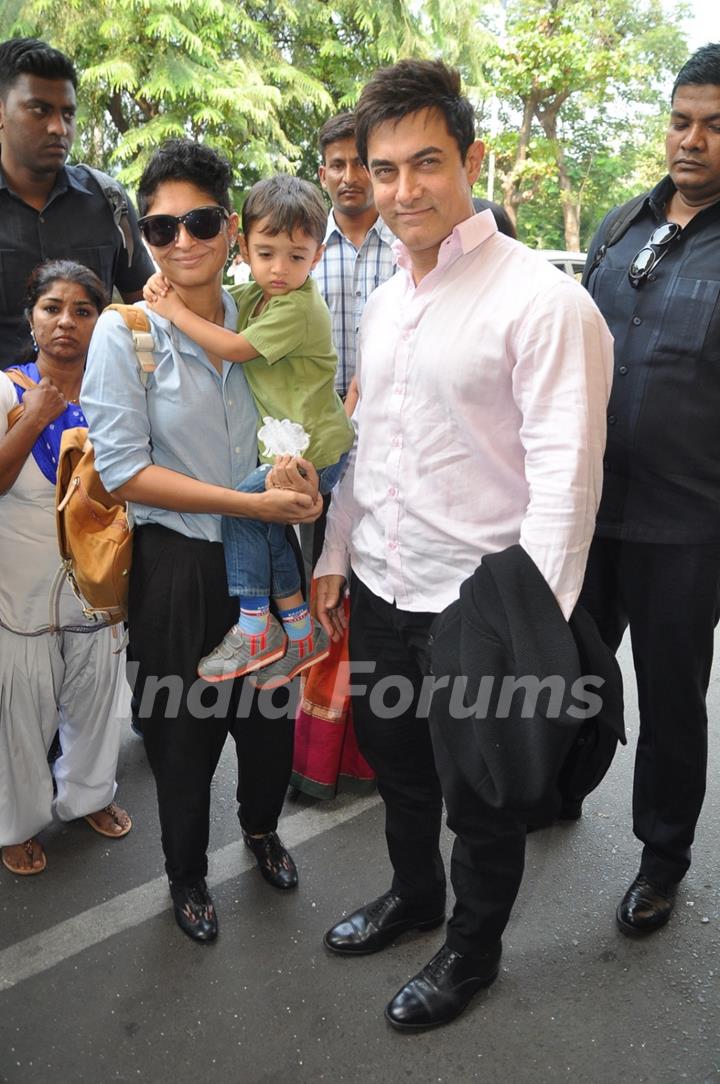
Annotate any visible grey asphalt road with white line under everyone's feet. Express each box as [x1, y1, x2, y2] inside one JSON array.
[[0, 633, 720, 1084]]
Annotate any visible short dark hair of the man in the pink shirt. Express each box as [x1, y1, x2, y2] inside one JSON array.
[[355, 60, 475, 166]]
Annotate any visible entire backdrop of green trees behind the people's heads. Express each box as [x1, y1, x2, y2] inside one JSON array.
[[0, 0, 686, 241]]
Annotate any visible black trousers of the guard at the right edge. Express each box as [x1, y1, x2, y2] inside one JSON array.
[[580, 539, 720, 883]]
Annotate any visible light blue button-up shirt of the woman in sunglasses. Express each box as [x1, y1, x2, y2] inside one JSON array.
[[81, 293, 257, 542]]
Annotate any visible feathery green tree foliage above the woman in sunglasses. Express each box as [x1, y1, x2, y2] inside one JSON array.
[[7, 0, 333, 186]]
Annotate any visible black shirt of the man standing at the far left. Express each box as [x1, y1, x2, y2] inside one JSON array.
[[0, 158, 154, 369]]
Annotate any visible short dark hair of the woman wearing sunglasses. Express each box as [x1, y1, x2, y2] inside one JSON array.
[[138, 139, 232, 218]]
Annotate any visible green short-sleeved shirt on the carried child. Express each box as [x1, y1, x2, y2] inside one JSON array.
[[230, 279, 353, 469]]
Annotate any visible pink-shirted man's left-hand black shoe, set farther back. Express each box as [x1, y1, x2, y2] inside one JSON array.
[[322, 892, 445, 956]]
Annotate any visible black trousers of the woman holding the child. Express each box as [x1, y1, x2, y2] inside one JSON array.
[[128, 525, 294, 886]]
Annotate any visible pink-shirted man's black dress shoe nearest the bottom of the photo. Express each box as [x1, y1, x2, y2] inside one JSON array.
[[385, 944, 501, 1031]]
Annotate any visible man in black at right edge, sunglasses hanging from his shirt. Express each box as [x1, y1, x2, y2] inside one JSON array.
[[580, 43, 720, 934]]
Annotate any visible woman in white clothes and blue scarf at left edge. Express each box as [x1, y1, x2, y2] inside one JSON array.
[[0, 260, 131, 876]]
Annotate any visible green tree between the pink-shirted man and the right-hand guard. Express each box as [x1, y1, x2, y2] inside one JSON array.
[[492, 0, 686, 249]]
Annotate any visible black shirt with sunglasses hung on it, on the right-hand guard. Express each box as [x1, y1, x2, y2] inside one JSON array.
[[588, 177, 720, 543]]
